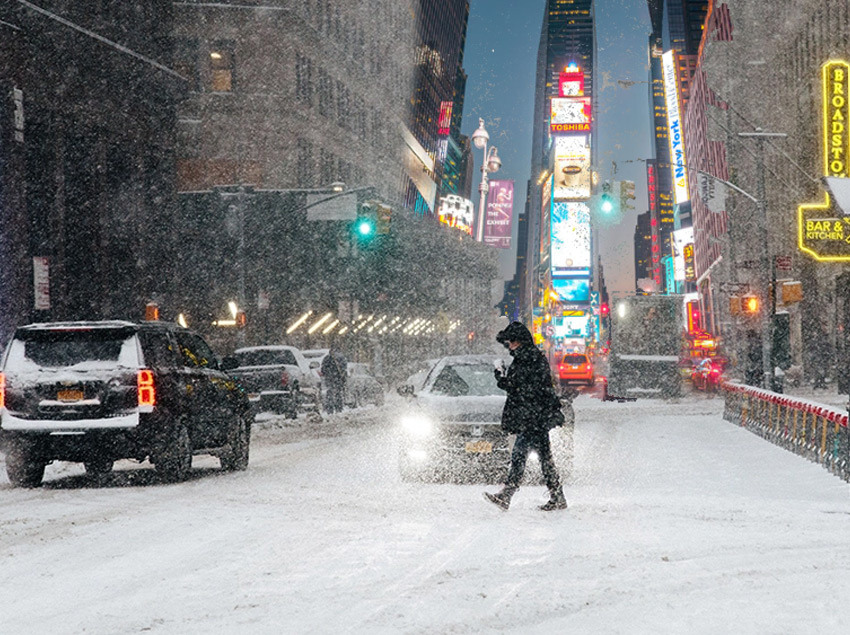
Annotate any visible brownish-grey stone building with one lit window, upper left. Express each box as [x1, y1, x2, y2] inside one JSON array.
[[173, 0, 412, 201]]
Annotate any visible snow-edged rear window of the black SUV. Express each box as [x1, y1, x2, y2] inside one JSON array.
[[7, 329, 138, 368]]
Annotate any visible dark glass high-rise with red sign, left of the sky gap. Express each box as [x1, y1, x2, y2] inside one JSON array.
[[404, 0, 469, 214]]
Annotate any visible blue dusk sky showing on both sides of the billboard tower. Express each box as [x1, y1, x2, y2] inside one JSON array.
[[462, 0, 651, 293]]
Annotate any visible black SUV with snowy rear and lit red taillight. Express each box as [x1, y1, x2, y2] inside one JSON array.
[[0, 321, 253, 487]]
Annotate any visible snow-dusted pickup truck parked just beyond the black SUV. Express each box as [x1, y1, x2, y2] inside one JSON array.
[[233, 345, 321, 419]]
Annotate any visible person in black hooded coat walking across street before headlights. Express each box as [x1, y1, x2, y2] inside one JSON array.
[[484, 322, 567, 511]]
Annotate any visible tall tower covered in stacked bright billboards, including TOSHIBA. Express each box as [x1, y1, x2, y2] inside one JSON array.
[[518, 0, 596, 350]]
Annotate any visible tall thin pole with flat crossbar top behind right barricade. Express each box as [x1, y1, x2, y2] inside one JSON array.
[[738, 128, 788, 390]]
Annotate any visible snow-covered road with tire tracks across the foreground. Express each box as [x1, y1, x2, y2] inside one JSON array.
[[0, 397, 850, 634]]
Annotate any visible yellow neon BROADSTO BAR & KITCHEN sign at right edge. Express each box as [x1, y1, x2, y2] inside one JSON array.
[[797, 60, 850, 262]]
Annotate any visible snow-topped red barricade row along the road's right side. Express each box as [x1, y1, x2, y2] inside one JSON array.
[[722, 382, 850, 481]]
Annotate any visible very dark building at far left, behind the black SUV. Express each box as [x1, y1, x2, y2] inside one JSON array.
[[0, 0, 179, 344]]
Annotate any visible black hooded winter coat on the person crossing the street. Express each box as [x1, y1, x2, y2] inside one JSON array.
[[496, 322, 564, 434]]
